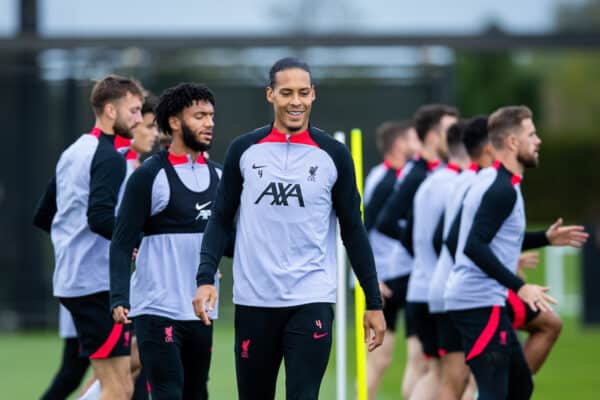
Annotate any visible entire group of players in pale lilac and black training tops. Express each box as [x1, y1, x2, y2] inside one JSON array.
[[34, 58, 587, 400]]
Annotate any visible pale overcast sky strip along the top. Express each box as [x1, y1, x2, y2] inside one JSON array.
[[0, 0, 581, 36]]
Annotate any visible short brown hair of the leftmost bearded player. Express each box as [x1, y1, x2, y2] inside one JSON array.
[[90, 75, 144, 115]]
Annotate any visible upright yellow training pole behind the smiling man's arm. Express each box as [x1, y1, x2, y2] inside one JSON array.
[[350, 129, 367, 400]]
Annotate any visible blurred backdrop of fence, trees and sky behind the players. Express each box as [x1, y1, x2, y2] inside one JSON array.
[[0, 0, 600, 399]]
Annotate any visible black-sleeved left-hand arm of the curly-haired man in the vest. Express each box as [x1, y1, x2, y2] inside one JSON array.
[[110, 166, 156, 310]]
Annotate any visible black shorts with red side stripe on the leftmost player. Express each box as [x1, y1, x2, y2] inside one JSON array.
[[59, 292, 131, 360]]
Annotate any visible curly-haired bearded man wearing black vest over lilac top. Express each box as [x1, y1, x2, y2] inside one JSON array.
[[110, 83, 221, 400]]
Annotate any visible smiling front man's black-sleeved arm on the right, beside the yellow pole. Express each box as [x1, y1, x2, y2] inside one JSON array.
[[331, 147, 382, 310]]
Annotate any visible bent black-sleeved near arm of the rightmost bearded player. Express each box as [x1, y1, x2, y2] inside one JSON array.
[[464, 182, 525, 293]]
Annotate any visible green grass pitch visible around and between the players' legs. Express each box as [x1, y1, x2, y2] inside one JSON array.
[[0, 320, 600, 400]]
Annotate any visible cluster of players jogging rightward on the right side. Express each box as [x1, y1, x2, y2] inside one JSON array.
[[365, 104, 588, 400]]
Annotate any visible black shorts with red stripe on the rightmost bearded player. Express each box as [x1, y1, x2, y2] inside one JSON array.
[[448, 306, 521, 363]]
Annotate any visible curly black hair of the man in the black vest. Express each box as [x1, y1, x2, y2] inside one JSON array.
[[154, 82, 215, 134]]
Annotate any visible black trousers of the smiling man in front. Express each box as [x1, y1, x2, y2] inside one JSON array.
[[235, 303, 333, 400]]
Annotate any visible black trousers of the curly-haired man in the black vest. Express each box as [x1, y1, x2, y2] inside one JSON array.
[[133, 315, 215, 400]]
